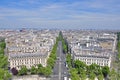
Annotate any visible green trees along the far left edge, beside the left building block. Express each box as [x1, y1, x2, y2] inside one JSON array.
[[0, 39, 11, 80]]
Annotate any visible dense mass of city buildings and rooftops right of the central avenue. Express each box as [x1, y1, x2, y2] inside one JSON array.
[[63, 31, 117, 67]]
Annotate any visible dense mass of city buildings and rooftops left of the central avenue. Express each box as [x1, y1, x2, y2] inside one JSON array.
[[0, 30, 59, 69]]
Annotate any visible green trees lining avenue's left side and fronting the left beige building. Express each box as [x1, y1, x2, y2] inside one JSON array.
[[17, 37, 59, 77]]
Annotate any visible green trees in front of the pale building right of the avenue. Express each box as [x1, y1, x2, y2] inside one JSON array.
[[66, 54, 110, 80]]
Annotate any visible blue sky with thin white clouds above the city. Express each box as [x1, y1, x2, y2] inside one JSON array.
[[0, 0, 120, 30]]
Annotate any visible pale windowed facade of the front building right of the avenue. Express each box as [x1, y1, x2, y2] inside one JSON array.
[[74, 55, 111, 67]]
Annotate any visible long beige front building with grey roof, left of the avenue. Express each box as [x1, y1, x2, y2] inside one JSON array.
[[9, 53, 48, 70]]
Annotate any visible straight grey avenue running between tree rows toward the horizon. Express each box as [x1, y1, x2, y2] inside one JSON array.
[[51, 41, 68, 80]]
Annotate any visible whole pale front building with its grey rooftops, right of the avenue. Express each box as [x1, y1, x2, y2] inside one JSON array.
[[73, 49, 111, 67]]
